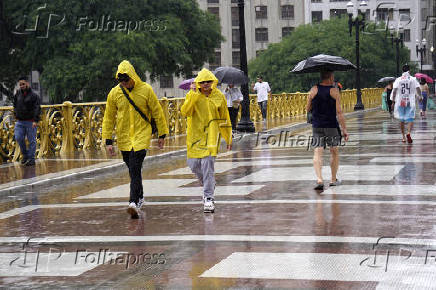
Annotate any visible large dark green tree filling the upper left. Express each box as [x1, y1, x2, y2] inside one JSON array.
[[0, 0, 222, 103]]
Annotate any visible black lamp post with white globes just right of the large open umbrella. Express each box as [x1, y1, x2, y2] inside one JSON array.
[[347, 0, 368, 111]]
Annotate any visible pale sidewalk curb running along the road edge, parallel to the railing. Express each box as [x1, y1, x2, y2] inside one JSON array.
[[0, 107, 379, 196]]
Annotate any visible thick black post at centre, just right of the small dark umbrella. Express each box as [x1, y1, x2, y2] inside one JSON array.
[[237, 0, 255, 132]]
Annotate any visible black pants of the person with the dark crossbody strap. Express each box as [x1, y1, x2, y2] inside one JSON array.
[[121, 149, 147, 203]]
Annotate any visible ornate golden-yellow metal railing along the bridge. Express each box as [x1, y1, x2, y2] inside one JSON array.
[[0, 89, 383, 162]]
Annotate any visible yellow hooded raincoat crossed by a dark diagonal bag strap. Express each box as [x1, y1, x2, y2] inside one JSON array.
[[102, 60, 168, 151]]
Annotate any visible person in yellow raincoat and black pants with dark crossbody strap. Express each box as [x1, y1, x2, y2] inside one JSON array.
[[102, 60, 168, 218]]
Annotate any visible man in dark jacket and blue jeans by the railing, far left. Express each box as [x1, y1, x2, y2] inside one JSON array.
[[14, 77, 41, 166]]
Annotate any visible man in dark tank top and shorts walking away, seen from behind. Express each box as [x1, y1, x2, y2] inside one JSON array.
[[306, 71, 348, 190]]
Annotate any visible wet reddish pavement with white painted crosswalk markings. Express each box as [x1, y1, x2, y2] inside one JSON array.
[[0, 111, 436, 289]]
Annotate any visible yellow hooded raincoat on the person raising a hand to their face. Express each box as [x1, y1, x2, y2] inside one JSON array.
[[181, 69, 232, 158]]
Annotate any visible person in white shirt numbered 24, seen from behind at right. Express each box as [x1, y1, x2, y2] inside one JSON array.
[[391, 64, 422, 143]]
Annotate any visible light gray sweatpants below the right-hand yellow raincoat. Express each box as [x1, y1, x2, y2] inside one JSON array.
[[188, 156, 215, 198]]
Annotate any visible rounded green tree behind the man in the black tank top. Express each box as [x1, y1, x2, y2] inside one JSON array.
[[249, 18, 410, 93]]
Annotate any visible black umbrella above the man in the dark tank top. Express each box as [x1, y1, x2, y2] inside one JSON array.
[[291, 54, 356, 73]]
